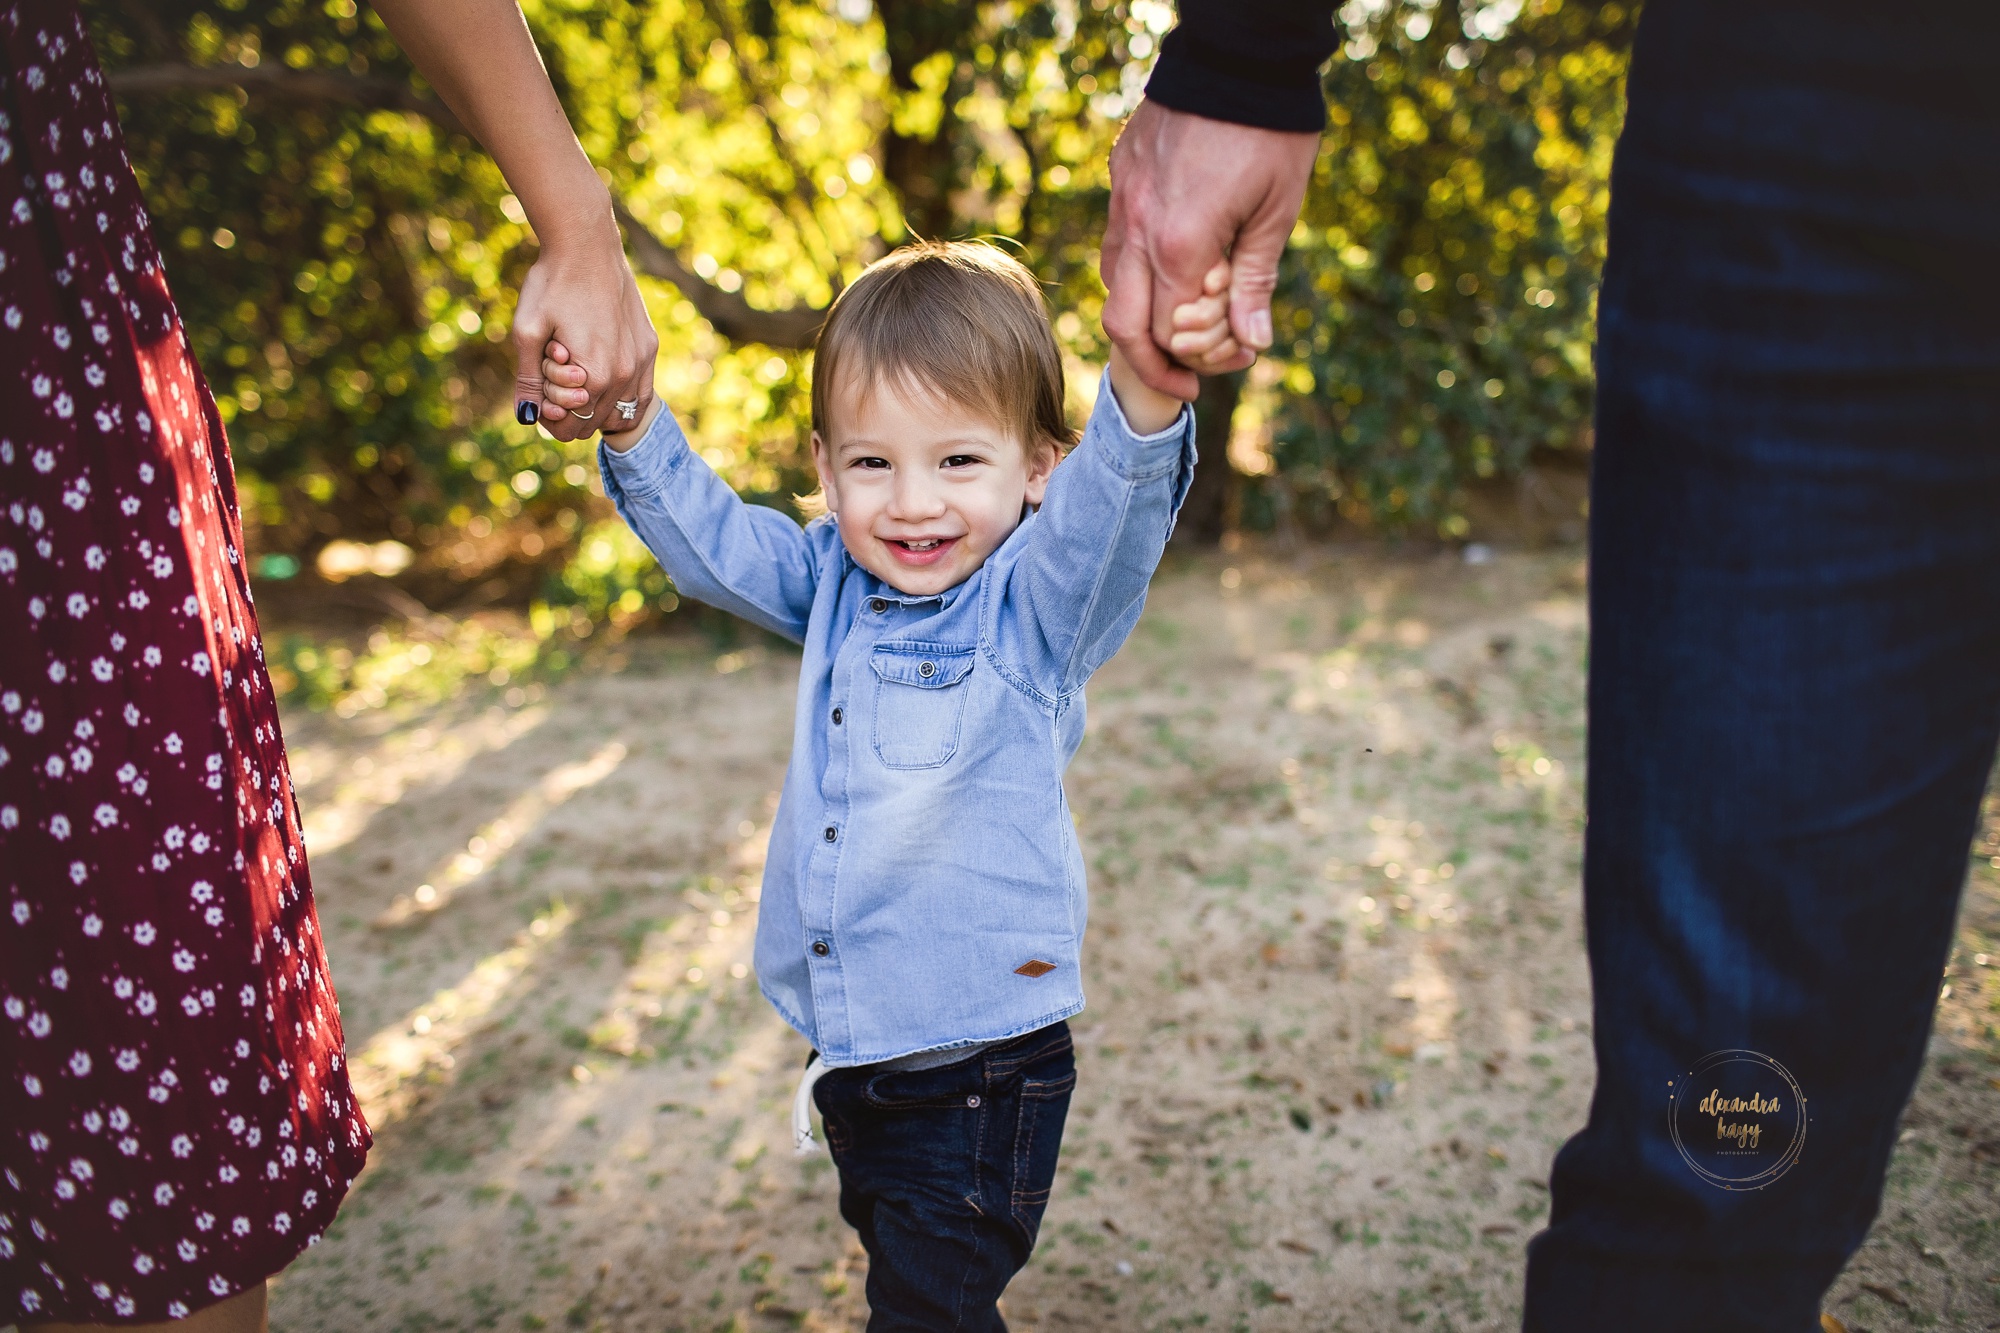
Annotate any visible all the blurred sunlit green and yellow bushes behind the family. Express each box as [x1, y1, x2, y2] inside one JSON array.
[[86, 0, 1636, 644]]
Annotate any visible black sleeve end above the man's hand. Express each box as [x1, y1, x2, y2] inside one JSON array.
[[1146, 0, 1340, 134]]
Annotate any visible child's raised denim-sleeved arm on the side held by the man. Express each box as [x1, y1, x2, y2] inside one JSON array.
[[986, 352, 1194, 699]]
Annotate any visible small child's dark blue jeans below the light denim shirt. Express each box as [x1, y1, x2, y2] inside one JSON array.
[[812, 1023, 1076, 1333]]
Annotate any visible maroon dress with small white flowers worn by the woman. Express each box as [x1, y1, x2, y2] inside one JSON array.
[[0, 0, 368, 1323]]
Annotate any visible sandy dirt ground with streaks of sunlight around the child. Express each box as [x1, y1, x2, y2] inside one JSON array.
[[227, 548, 2000, 1333]]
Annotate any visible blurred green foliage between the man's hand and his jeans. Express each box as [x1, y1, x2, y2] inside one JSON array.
[[1272, 0, 1636, 536]]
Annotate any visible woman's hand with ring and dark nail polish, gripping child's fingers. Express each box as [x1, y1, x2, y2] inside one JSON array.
[[514, 213, 660, 440]]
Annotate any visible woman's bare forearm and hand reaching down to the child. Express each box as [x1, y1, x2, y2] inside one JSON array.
[[374, 0, 660, 440]]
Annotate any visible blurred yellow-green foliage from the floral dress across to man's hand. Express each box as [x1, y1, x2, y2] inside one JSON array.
[[86, 0, 1170, 592]]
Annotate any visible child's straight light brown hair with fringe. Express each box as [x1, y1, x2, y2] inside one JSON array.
[[812, 240, 1076, 450]]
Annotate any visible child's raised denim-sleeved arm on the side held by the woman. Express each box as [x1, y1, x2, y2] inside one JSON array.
[[598, 402, 818, 642]]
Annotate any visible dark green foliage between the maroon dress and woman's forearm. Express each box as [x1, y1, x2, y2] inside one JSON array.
[[88, 0, 548, 548]]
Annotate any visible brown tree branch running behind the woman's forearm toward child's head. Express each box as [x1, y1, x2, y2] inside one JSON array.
[[106, 64, 826, 350]]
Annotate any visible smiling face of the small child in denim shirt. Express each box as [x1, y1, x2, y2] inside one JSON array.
[[812, 376, 1056, 596]]
